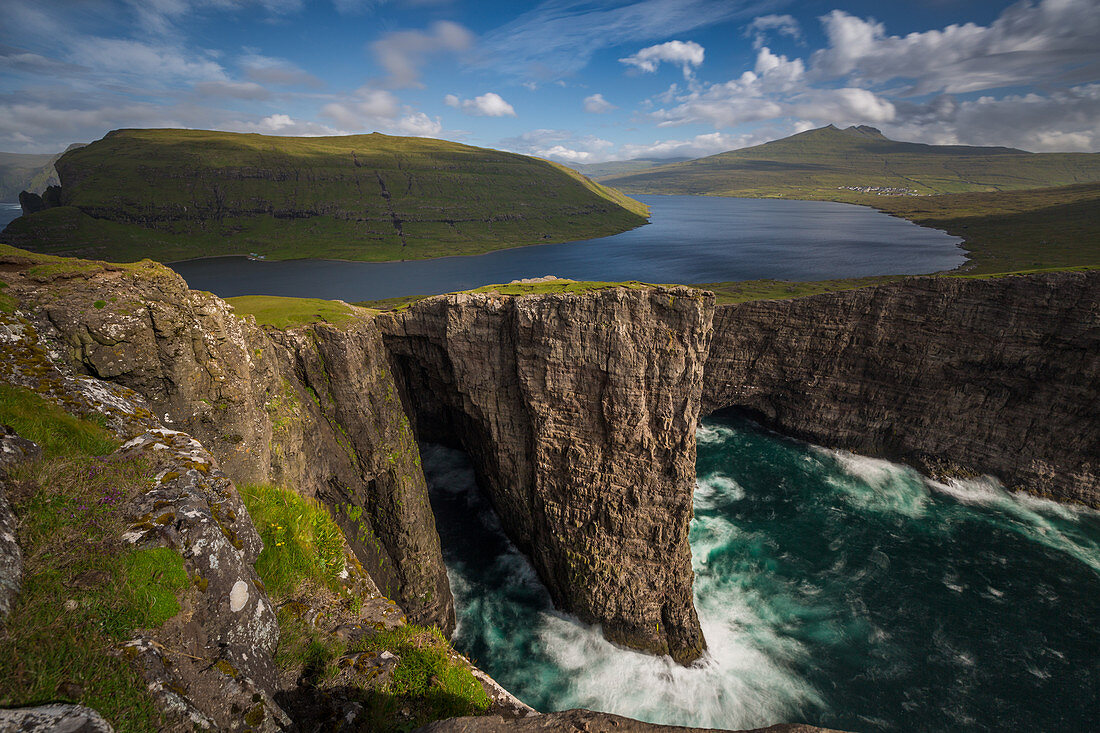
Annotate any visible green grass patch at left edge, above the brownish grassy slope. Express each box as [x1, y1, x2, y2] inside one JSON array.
[[0, 383, 119, 458]]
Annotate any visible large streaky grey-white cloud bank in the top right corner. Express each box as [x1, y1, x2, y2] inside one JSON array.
[[811, 0, 1100, 95]]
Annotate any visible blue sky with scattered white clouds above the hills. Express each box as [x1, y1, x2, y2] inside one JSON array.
[[0, 0, 1100, 164]]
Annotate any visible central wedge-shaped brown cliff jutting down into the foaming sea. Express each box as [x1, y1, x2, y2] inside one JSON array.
[[380, 288, 713, 663]]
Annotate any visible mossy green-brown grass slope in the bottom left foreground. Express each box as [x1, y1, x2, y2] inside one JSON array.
[[0, 400, 188, 731]]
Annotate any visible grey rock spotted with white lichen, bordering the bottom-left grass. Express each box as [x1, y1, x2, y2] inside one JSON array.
[[0, 303, 289, 731]]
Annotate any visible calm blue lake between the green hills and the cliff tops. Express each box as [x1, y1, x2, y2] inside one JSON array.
[[162, 196, 966, 302]]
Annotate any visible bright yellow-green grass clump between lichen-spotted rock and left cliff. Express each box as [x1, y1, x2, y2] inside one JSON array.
[[239, 484, 344, 598]]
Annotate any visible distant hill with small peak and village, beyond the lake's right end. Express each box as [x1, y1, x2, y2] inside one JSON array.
[[601, 125, 1100, 197]]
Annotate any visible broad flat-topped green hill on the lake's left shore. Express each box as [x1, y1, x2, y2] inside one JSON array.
[[0, 130, 648, 261]]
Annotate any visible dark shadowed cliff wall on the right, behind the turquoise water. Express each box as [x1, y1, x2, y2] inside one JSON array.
[[703, 272, 1100, 506]]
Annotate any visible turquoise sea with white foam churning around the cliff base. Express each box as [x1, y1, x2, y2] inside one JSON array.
[[425, 418, 1100, 731]]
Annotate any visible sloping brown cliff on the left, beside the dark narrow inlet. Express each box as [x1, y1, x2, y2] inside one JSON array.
[[0, 256, 454, 632]]
